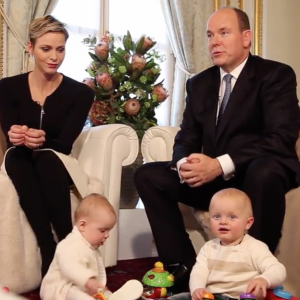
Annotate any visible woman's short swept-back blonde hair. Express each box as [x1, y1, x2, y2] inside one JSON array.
[[29, 15, 69, 45]]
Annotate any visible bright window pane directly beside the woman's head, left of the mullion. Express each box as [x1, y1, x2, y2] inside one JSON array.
[[52, 0, 100, 82]]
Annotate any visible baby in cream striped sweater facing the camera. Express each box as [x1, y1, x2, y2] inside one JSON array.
[[190, 188, 286, 300]]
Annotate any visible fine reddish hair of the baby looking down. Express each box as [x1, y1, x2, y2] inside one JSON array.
[[75, 193, 116, 222]]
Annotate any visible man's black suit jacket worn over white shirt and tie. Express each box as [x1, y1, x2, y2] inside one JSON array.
[[171, 54, 300, 184]]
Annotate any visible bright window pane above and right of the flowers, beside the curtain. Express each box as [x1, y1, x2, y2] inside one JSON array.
[[109, 0, 174, 125]]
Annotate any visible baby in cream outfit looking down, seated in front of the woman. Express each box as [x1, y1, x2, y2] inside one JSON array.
[[40, 194, 143, 300]]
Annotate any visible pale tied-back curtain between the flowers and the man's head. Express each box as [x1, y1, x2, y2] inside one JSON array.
[[161, 0, 214, 126]]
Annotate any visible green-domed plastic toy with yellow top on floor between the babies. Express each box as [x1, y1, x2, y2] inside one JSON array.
[[142, 262, 174, 299]]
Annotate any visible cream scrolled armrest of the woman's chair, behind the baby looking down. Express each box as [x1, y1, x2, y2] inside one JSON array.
[[72, 124, 139, 267]]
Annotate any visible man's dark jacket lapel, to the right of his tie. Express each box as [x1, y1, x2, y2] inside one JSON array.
[[216, 55, 254, 142]]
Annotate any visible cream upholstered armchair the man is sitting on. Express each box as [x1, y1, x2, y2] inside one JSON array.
[[141, 126, 300, 298]]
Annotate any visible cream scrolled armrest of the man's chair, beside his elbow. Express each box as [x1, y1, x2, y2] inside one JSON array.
[[141, 126, 179, 162]]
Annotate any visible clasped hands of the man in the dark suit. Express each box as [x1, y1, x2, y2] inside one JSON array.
[[179, 153, 223, 187]]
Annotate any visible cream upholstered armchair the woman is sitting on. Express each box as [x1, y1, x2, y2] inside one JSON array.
[[0, 124, 139, 293]]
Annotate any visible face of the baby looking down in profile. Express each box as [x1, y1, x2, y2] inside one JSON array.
[[81, 213, 116, 249]]
